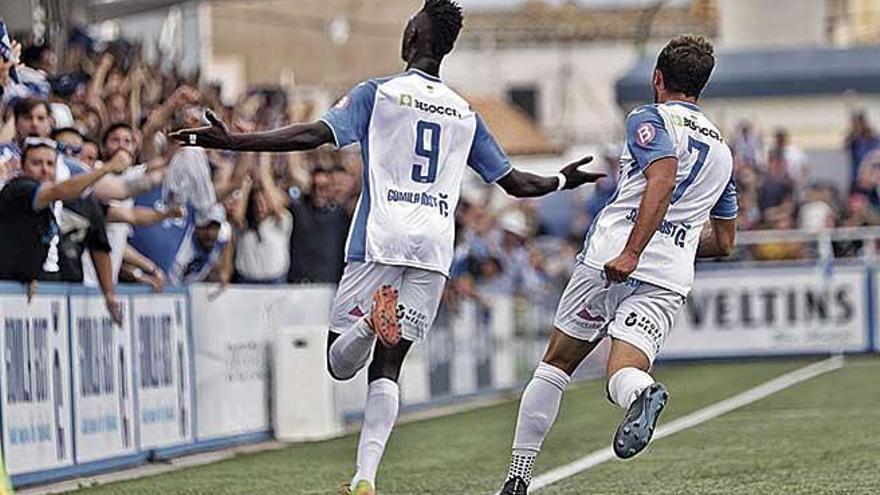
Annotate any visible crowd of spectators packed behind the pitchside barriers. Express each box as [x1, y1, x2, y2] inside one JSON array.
[[0, 31, 880, 318]]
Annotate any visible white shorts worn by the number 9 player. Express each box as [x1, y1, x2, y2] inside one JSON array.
[[330, 262, 446, 342]]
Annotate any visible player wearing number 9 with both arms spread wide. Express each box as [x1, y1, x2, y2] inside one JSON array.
[[171, 0, 604, 495]]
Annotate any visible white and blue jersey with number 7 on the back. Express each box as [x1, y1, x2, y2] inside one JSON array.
[[579, 101, 737, 296]]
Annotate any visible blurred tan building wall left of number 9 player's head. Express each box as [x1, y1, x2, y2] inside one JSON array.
[[203, 0, 422, 91]]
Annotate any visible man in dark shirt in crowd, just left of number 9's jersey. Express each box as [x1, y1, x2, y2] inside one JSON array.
[[287, 169, 351, 284]]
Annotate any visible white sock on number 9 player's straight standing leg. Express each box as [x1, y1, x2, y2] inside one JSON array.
[[351, 378, 400, 489]]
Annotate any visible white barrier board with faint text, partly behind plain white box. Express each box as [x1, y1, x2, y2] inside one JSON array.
[[191, 285, 334, 440]]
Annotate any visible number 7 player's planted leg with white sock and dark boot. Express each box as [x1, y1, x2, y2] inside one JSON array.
[[501, 329, 598, 495]]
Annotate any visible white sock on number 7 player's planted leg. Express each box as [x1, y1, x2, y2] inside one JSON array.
[[507, 362, 571, 484]]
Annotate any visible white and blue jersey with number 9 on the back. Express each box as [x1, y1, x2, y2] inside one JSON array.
[[321, 70, 511, 276]]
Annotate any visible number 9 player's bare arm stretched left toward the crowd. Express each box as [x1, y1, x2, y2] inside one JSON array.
[[169, 110, 333, 152]]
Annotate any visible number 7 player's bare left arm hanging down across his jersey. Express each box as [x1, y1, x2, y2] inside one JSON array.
[[605, 157, 678, 283]]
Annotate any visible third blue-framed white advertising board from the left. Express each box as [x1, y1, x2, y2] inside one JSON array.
[[132, 294, 193, 449]]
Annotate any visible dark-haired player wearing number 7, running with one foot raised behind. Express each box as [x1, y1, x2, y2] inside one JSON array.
[[501, 35, 737, 495]]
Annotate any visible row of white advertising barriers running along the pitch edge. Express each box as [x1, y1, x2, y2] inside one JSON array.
[[0, 266, 880, 490]]
